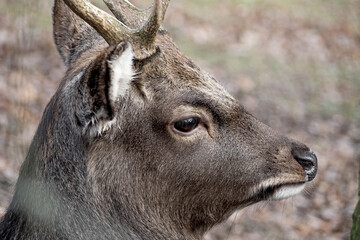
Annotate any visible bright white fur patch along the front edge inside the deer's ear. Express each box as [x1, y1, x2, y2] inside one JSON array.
[[109, 44, 134, 101]]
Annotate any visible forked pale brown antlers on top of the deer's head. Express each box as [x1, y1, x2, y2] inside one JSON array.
[[64, 0, 170, 59]]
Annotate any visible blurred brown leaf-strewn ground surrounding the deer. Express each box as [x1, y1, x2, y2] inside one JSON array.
[[0, 0, 360, 240]]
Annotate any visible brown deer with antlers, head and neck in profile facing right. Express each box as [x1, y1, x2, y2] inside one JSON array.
[[0, 0, 318, 240]]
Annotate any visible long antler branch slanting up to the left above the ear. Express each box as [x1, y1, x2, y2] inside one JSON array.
[[64, 0, 133, 44]]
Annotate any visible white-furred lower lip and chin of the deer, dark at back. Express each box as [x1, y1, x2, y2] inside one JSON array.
[[258, 182, 305, 200]]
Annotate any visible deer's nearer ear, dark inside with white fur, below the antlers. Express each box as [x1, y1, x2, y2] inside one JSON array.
[[83, 42, 134, 135]]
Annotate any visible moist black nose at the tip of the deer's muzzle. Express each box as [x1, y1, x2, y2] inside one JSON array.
[[294, 151, 317, 181]]
